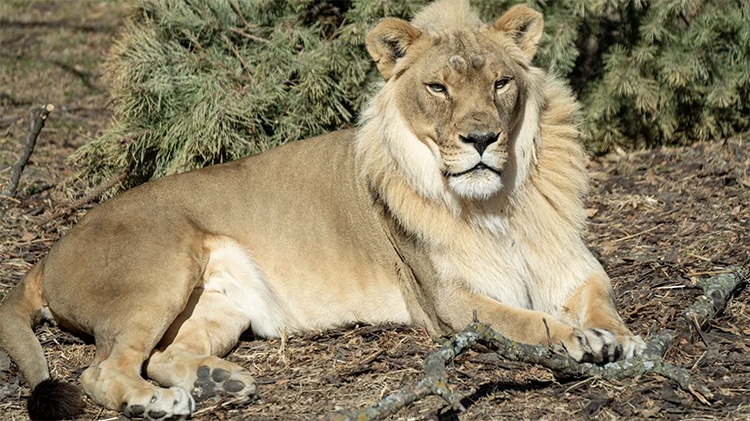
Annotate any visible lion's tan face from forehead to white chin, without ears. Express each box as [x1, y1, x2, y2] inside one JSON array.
[[398, 34, 520, 199]]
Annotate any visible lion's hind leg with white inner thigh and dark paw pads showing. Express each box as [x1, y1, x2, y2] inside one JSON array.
[[146, 235, 295, 401]]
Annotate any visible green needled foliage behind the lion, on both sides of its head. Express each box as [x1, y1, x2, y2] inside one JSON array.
[[72, 0, 750, 187]]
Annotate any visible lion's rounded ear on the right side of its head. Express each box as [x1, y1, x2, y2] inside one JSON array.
[[493, 4, 544, 61]]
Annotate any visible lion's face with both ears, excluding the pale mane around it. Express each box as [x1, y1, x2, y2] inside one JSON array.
[[368, 4, 542, 200]]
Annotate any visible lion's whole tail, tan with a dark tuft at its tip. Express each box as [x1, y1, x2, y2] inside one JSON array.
[[0, 260, 83, 420]]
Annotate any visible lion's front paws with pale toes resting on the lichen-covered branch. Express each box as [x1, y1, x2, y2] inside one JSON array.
[[563, 329, 646, 363]]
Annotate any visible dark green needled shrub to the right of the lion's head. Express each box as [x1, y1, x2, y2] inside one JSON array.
[[565, 0, 750, 151]]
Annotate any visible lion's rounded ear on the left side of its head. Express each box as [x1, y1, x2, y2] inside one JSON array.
[[365, 18, 420, 80]]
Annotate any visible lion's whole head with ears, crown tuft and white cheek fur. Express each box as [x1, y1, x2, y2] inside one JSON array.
[[364, 0, 544, 201]]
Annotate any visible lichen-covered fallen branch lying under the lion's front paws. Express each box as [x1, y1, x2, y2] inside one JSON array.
[[334, 268, 746, 421]]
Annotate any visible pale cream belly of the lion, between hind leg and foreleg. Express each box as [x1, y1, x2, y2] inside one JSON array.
[[203, 236, 411, 337]]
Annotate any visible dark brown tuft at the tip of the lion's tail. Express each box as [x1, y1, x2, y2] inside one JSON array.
[[27, 379, 83, 420]]
